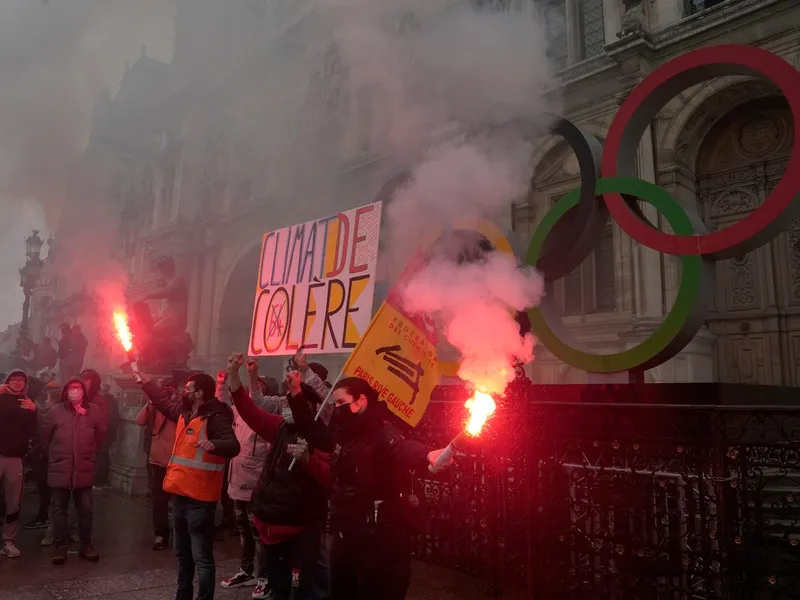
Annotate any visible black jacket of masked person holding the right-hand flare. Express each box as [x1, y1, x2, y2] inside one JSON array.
[[331, 402, 430, 535]]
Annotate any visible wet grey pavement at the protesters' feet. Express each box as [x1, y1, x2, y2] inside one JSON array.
[[0, 491, 489, 600]]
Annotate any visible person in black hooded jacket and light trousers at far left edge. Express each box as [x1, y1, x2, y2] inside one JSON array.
[[0, 371, 36, 558]]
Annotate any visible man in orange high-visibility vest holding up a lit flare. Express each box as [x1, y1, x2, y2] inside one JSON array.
[[136, 373, 240, 600]]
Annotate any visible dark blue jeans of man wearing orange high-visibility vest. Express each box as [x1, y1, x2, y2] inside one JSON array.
[[172, 496, 216, 600]]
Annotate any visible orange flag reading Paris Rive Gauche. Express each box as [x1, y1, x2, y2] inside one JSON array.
[[343, 256, 439, 427]]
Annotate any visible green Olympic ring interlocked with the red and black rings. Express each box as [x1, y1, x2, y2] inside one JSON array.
[[525, 177, 714, 373]]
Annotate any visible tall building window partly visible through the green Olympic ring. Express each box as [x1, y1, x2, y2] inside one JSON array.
[[557, 224, 616, 316]]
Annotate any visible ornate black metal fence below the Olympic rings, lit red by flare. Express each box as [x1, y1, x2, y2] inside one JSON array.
[[410, 382, 800, 600]]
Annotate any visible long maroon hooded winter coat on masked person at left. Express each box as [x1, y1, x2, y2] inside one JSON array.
[[41, 377, 106, 489]]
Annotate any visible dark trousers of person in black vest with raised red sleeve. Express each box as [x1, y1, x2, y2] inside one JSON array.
[[266, 527, 320, 600]]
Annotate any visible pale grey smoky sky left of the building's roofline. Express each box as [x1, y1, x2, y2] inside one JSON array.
[[0, 0, 174, 329]]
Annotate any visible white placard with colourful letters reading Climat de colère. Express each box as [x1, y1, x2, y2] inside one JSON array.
[[248, 202, 381, 356]]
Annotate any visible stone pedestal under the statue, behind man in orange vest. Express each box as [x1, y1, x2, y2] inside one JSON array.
[[111, 375, 148, 496]]
